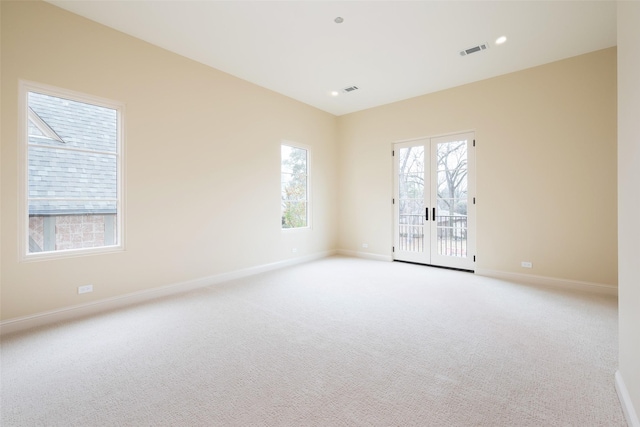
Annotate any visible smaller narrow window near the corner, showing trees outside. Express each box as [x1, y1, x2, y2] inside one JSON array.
[[280, 144, 309, 229]]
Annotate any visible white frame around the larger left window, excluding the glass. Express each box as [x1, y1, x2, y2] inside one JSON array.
[[18, 80, 125, 262]]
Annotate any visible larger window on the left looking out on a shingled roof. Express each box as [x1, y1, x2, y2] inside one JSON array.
[[20, 82, 122, 259]]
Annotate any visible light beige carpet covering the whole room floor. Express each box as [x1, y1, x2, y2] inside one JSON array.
[[0, 257, 625, 427]]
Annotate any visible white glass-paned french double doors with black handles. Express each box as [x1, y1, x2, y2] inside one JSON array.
[[393, 133, 475, 270]]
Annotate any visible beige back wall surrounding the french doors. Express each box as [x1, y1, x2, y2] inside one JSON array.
[[338, 48, 617, 285]]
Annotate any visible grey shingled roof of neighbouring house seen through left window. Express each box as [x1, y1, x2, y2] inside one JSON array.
[[29, 92, 117, 215]]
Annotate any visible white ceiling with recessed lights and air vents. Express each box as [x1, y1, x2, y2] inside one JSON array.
[[49, 0, 616, 115]]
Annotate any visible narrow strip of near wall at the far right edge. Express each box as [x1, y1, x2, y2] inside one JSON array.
[[618, 1, 640, 422]]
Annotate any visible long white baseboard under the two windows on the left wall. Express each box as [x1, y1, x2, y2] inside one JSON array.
[[0, 251, 336, 335]]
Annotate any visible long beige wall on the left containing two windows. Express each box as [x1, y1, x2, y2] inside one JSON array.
[[1, 1, 337, 319]]
